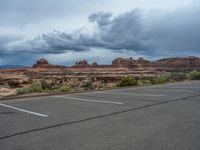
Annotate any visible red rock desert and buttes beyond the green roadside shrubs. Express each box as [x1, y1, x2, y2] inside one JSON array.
[[0, 56, 200, 97]]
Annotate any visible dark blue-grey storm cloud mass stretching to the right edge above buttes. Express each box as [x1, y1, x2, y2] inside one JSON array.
[[1, 6, 200, 55]]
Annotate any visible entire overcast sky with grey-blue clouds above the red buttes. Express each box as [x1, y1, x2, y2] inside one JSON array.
[[0, 0, 200, 66]]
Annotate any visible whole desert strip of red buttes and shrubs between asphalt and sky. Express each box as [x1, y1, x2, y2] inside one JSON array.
[[0, 56, 200, 97]]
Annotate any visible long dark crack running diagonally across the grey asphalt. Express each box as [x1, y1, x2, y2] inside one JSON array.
[[0, 95, 200, 140]]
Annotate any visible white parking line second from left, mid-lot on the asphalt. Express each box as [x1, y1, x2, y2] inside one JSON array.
[[53, 96, 123, 105]]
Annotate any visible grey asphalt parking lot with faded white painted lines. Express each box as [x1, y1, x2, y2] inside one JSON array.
[[0, 81, 200, 150]]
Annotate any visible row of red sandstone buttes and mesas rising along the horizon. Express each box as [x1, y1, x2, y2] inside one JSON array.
[[33, 56, 200, 70]]
